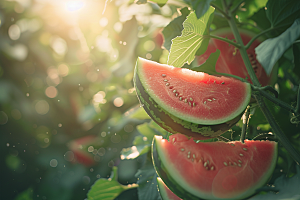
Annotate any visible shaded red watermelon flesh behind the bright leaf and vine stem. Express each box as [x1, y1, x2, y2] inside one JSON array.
[[198, 28, 271, 86]]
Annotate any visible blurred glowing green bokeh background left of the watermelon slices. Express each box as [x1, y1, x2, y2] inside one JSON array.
[[0, 0, 173, 200]]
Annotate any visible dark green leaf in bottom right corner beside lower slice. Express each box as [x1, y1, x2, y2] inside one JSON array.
[[250, 165, 300, 200]]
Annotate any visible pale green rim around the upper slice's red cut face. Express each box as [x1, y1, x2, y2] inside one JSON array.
[[135, 57, 251, 125]]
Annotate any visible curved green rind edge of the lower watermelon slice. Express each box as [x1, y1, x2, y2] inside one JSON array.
[[152, 136, 278, 200]]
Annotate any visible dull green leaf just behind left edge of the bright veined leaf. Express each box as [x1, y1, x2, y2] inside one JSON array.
[[162, 7, 190, 51]]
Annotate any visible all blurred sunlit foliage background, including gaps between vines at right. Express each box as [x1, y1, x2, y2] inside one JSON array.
[[0, 0, 300, 200]]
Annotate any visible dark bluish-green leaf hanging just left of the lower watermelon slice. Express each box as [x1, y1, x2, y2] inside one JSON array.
[[135, 159, 161, 200]]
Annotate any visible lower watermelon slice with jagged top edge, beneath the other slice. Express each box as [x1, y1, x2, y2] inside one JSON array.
[[152, 134, 277, 199]]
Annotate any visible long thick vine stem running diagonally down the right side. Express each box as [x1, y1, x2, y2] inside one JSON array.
[[222, 0, 300, 165]]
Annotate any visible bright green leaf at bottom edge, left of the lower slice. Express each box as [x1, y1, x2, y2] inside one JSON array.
[[87, 167, 138, 200]]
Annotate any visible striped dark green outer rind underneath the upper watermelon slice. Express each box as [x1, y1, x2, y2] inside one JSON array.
[[134, 65, 242, 140]]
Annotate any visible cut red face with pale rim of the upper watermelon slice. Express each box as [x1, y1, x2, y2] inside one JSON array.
[[136, 58, 251, 125]]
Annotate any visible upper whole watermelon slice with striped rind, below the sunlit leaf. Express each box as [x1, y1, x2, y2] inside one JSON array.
[[134, 58, 251, 139]]
